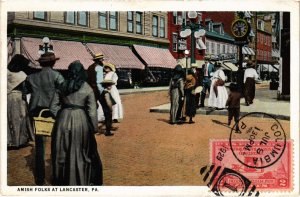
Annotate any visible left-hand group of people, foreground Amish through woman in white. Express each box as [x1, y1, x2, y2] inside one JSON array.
[[7, 52, 123, 186]]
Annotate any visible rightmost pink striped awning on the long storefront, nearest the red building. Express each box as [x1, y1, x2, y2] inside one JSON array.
[[133, 45, 176, 68]]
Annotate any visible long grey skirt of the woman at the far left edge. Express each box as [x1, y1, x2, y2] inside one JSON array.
[[7, 90, 34, 148]]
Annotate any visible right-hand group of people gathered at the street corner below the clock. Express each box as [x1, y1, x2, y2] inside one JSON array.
[[169, 60, 258, 125]]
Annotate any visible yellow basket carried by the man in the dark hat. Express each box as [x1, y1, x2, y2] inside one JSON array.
[[33, 109, 55, 136]]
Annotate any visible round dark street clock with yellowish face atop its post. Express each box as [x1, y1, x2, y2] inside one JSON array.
[[231, 19, 250, 40]]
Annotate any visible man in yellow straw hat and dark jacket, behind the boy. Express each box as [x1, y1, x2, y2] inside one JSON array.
[[87, 53, 104, 100]]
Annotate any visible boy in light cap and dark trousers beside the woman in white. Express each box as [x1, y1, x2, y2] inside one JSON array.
[[99, 79, 116, 136]]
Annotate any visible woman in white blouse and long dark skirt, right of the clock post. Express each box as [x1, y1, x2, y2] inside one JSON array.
[[244, 60, 258, 106]]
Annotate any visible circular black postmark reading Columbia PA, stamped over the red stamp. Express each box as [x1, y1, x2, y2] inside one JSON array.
[[229, 112, 286, 171]]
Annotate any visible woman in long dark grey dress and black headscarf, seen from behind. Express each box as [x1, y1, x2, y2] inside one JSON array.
[[50, 61, 103, 186]]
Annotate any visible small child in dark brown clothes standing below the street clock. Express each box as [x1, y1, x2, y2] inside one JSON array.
[[226, 83, 242, 130]]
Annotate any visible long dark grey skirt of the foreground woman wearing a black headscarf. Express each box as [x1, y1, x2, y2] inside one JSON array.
[[51, 109, 103, 186]]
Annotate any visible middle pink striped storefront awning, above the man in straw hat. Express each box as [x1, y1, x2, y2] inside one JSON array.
[[87, 43, 145, 69]]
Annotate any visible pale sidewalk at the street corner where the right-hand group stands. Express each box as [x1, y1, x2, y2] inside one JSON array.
[[150, 86, 290, 120]]
